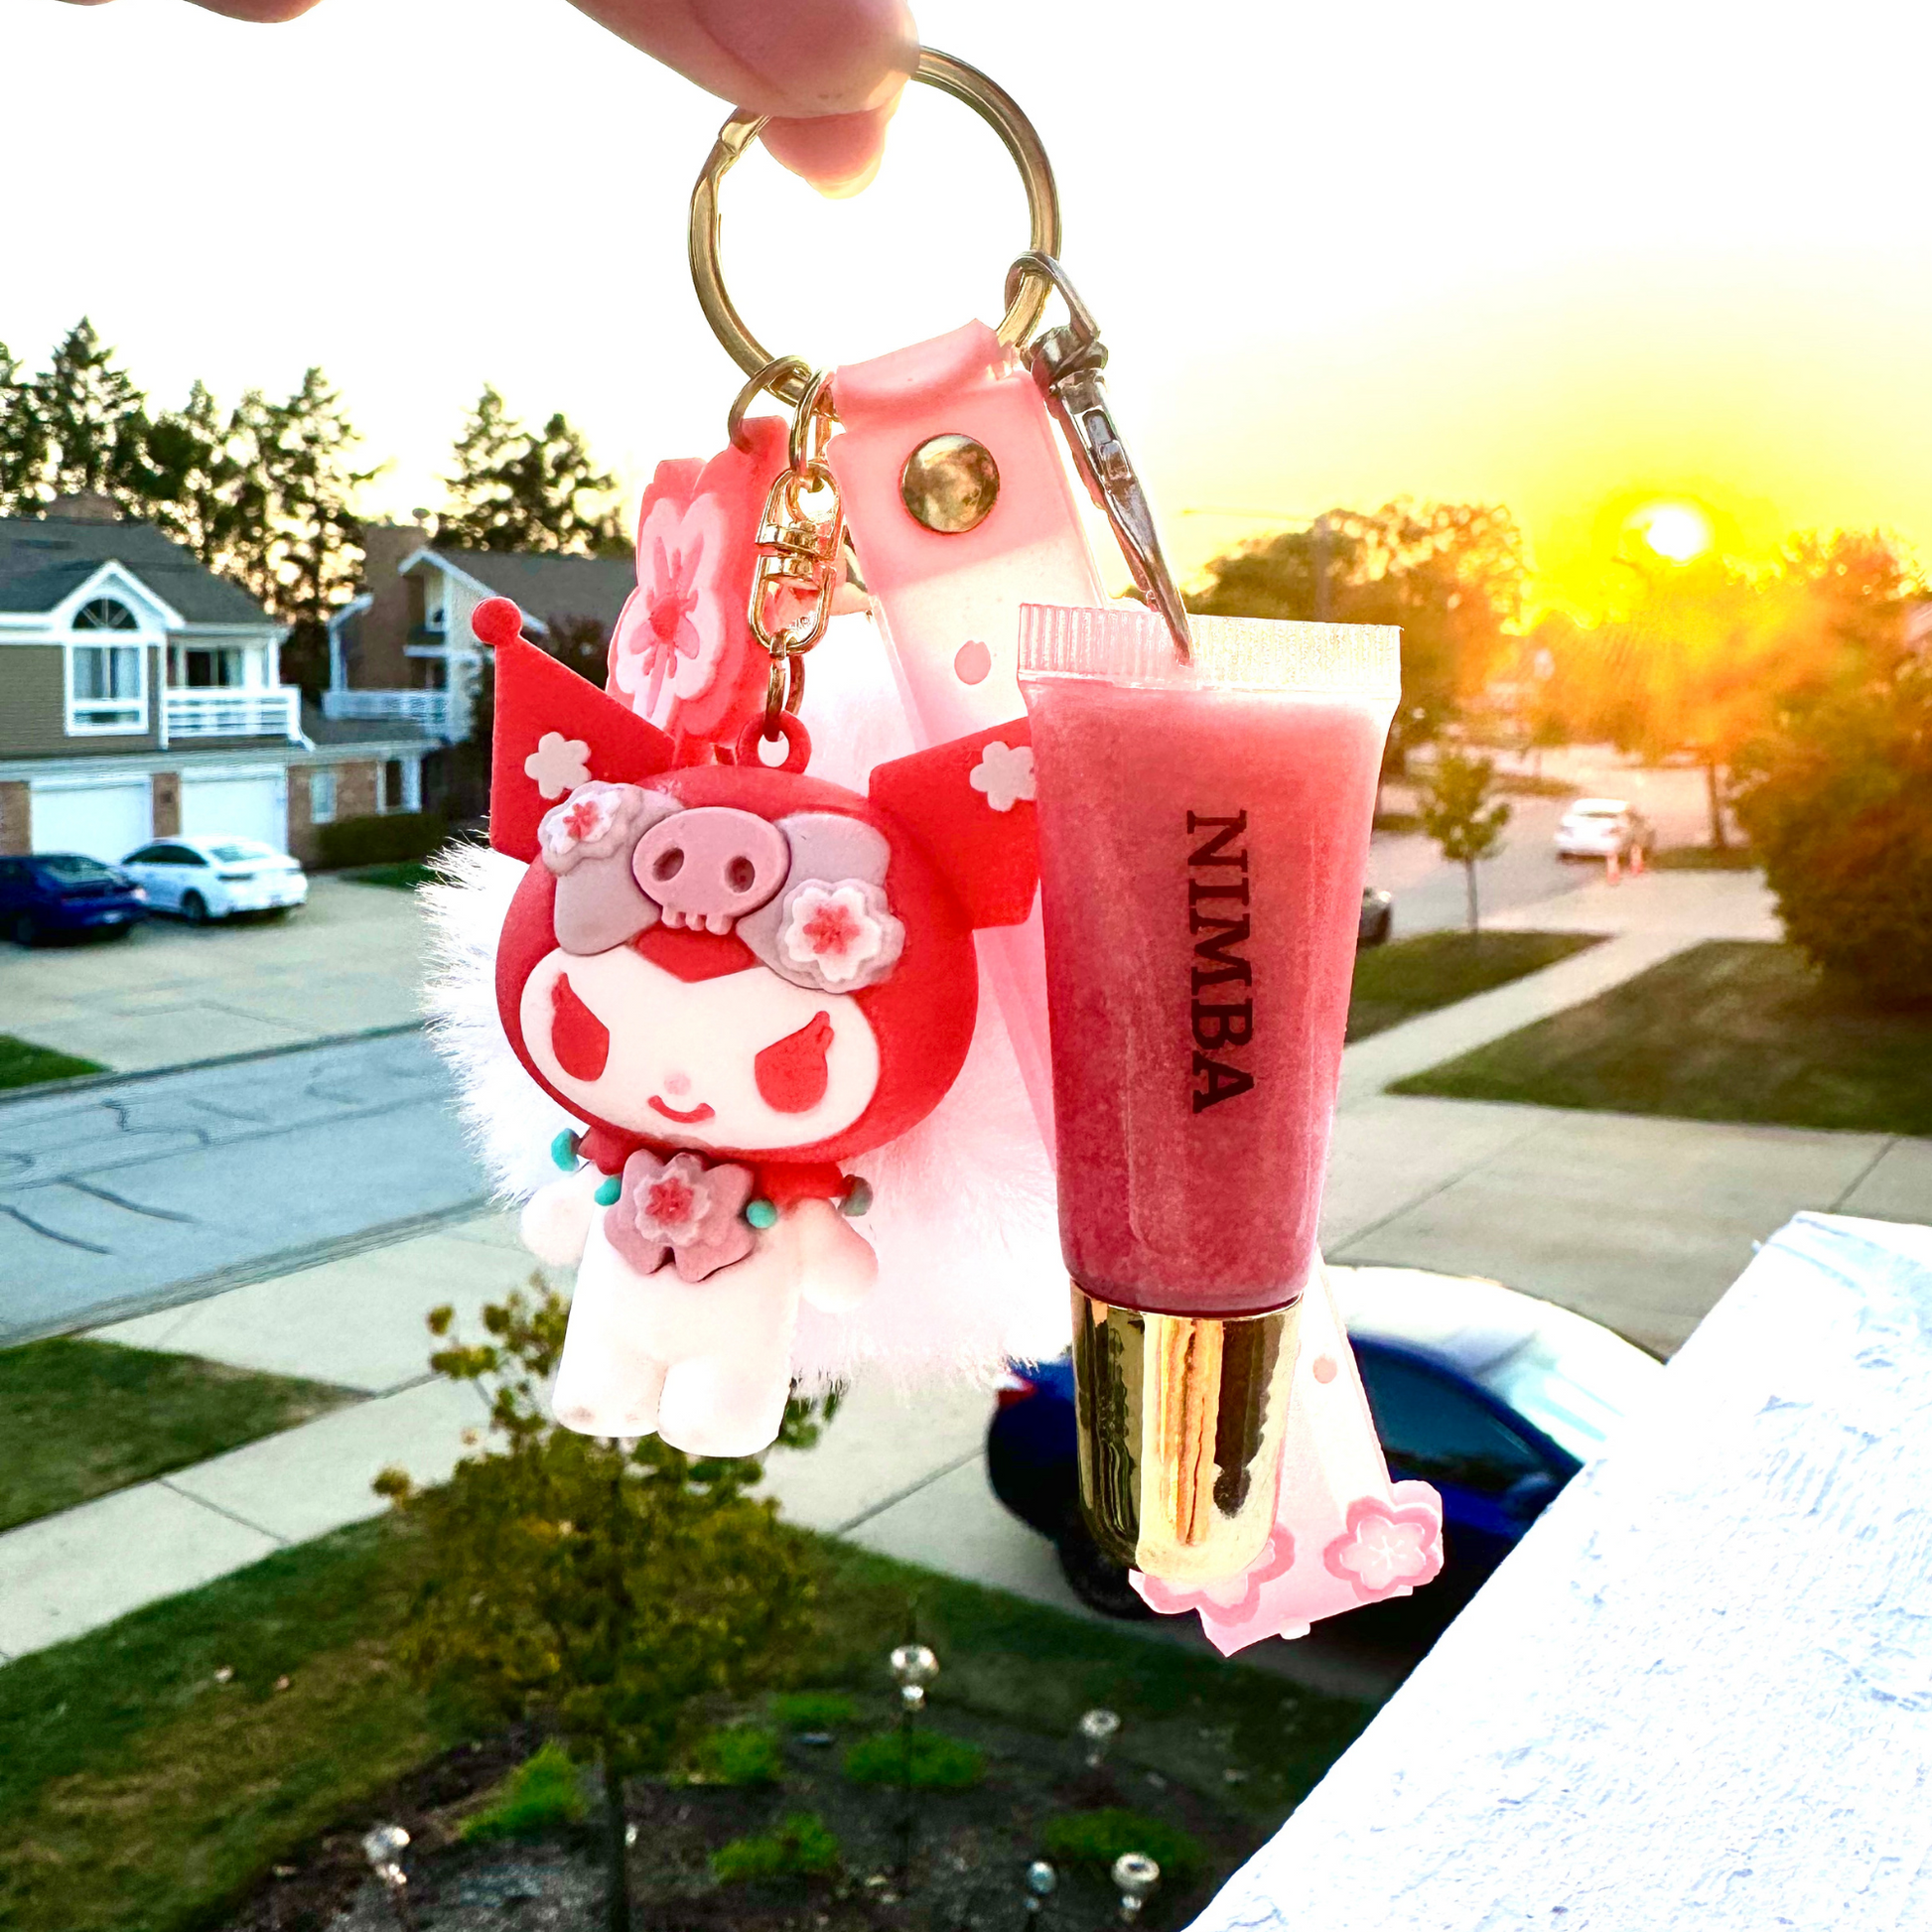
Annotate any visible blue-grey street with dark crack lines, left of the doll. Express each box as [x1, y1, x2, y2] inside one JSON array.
[[0, 1026, 488, 1344]]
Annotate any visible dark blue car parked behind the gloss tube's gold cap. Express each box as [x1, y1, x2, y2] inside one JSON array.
[[985, 1268, 1664, 1617]]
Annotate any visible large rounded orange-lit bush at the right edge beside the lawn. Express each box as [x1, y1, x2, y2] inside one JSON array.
[[1736, 662, 1932, 1005]]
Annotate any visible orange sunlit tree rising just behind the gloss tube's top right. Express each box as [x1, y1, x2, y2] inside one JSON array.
[[1188, 498, 1526, 772]]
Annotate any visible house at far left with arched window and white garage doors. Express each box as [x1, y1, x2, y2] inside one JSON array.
[[0, 496, 435, 862]]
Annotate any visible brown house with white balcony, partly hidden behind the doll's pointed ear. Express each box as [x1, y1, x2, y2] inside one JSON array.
[[323, 523, 637, 744]]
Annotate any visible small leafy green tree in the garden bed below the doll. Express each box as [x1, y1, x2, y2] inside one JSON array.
[[376, 1291, 815, 1932]]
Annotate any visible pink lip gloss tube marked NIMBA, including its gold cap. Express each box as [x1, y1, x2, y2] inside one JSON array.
[[1020, 605, 1399, 1583]]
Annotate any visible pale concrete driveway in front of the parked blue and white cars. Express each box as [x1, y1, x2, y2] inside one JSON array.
[[0, 877, 423, 1072]]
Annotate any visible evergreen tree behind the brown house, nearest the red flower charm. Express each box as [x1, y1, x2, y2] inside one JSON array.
[[437, 386, 629, 556]]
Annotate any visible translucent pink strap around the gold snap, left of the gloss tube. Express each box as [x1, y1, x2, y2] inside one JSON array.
[[827, 323, 1107, 1148]]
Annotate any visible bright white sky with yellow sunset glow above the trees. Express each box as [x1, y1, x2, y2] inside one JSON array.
[[0, 0, 1932, 609]]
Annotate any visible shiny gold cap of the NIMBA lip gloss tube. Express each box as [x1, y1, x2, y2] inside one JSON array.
[[1072, 1285, 1301, 1585]]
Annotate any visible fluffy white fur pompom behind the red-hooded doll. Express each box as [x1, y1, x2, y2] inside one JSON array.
[[423, 617, 1068, 1391]]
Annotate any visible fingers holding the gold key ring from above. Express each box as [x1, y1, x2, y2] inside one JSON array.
[[49, 0, 919, 196]]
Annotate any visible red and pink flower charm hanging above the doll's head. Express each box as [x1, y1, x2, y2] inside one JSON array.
[[611, 415, 784, 744]]
